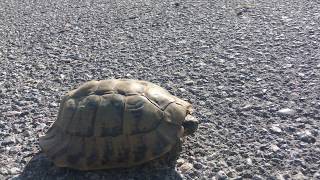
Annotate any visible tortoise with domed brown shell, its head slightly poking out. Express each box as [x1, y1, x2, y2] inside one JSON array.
[[39, 79, 198, 170]]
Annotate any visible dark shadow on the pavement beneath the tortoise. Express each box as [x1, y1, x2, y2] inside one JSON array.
[[14, 153, 182, 180]]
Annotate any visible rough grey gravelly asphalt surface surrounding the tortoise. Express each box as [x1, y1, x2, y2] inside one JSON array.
[[0, 0, 320, 180]]
